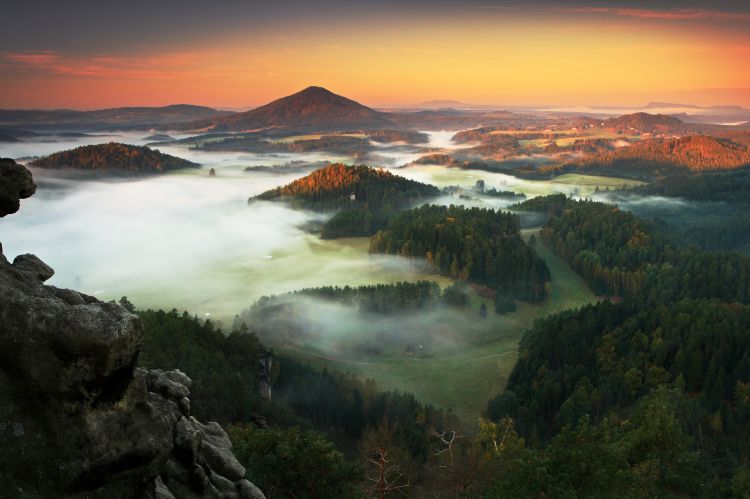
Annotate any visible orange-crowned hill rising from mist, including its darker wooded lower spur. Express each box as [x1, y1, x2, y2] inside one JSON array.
[[249, 163, 440, 238]]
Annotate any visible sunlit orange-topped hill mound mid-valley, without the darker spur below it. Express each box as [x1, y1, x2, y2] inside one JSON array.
[[250, 163, 440, 211]]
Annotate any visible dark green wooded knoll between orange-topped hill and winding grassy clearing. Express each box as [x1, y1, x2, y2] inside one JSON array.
[[370, 205, 550, 302]]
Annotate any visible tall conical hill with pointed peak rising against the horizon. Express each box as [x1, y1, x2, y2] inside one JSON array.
[[179, 86, 393, 132]]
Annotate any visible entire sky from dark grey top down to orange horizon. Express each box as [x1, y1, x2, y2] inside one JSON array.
[[0, 0, 750, 109]]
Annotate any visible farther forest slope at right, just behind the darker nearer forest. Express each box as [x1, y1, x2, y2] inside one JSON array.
[[519, 195, 750, 304]]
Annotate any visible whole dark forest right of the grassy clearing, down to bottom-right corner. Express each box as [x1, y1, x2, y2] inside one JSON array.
[[488, 195, 750, 497]]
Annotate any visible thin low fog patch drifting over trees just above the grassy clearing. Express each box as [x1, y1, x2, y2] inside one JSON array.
[[236, 294, 504, 360]]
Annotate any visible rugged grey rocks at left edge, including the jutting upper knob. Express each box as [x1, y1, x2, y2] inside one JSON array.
[[0, 160, 264, 499]]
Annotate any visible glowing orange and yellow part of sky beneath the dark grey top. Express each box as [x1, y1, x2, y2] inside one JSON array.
[[0, 9, 750, 109]]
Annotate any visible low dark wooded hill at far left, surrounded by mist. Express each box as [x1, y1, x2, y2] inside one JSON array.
[[30, 142, 200, 173]]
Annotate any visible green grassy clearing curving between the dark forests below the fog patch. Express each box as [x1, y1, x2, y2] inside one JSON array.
[[286, 230, 596, 426]]
